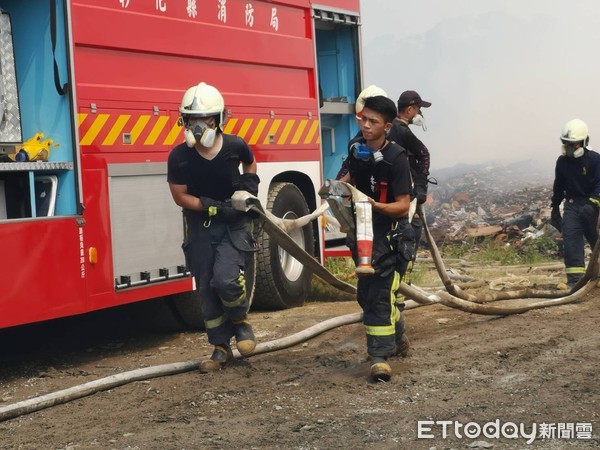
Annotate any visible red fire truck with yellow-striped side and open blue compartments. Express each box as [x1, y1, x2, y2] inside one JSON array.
[[0, 0, 361, 328]]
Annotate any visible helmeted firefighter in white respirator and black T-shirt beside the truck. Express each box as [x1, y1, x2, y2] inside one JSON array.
[[167, 83, 259, 372]]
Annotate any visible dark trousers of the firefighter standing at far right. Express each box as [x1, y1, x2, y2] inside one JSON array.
[[562, 198, 598, 284]]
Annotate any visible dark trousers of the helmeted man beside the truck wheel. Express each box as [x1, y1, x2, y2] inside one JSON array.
[[187, 215, 249, 345]]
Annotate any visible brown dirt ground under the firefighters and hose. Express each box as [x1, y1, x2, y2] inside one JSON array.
[[0, 289, 600, 450]]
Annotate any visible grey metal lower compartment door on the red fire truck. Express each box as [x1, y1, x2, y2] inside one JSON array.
[[108, 163, 185, 287]]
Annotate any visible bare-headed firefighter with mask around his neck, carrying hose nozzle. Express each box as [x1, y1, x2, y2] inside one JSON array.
[[341, 95, 414, 381]]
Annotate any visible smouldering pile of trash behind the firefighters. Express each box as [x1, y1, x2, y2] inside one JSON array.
[[426, 163, 559, 245]]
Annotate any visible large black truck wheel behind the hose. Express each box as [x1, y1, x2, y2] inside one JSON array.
[[254, 183, 314, 309]]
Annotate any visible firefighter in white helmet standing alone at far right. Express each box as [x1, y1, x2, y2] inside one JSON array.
[[550, 119, 600, 289]]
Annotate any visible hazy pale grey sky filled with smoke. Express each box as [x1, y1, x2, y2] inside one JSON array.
[[361, 0, 600, 171]]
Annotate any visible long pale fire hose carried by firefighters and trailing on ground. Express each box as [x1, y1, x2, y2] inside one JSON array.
[[0, 185, 600, 422]]
